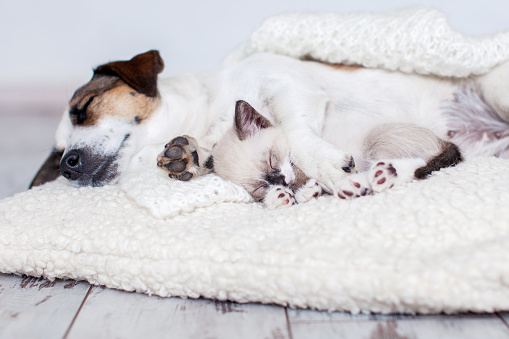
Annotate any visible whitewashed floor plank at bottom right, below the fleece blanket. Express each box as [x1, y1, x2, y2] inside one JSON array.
[[288, 310, 509, 339]]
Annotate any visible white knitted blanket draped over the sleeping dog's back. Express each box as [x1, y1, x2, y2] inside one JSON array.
[[226, 8, 509, 77]]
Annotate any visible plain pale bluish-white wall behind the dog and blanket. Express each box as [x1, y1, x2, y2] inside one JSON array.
[[0, 0, 509, 96]]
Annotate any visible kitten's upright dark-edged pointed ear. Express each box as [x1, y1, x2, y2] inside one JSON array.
[[235, 100, 272, 140]]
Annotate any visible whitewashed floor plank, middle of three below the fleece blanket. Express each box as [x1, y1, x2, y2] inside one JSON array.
[[67, 287, 289, 339]]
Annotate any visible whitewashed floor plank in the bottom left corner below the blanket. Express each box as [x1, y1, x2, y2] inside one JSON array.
[[0, 274, 90, 338]]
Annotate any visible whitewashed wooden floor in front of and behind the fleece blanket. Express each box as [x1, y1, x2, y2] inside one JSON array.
[[0, 99, 509, 339]]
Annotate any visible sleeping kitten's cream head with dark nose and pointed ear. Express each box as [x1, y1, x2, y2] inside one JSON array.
[[213, 101, 308, 201]]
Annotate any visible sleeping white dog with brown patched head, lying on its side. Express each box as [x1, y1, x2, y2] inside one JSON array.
[[30, 51, 509, 198]]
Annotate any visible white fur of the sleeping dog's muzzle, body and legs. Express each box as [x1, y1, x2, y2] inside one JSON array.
[[56, 54, 509, 191]]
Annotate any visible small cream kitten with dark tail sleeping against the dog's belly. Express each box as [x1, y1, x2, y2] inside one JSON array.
[[208, 101, 462, 208]]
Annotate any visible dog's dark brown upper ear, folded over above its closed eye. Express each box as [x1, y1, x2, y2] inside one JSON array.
[[94, 50, 164, 97]]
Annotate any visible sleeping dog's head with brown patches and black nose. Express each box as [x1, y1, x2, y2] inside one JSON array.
[[32, 51, 164, 186]]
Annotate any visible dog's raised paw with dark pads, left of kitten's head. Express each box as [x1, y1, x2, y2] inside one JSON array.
[[157, 135, 213, 181]]
